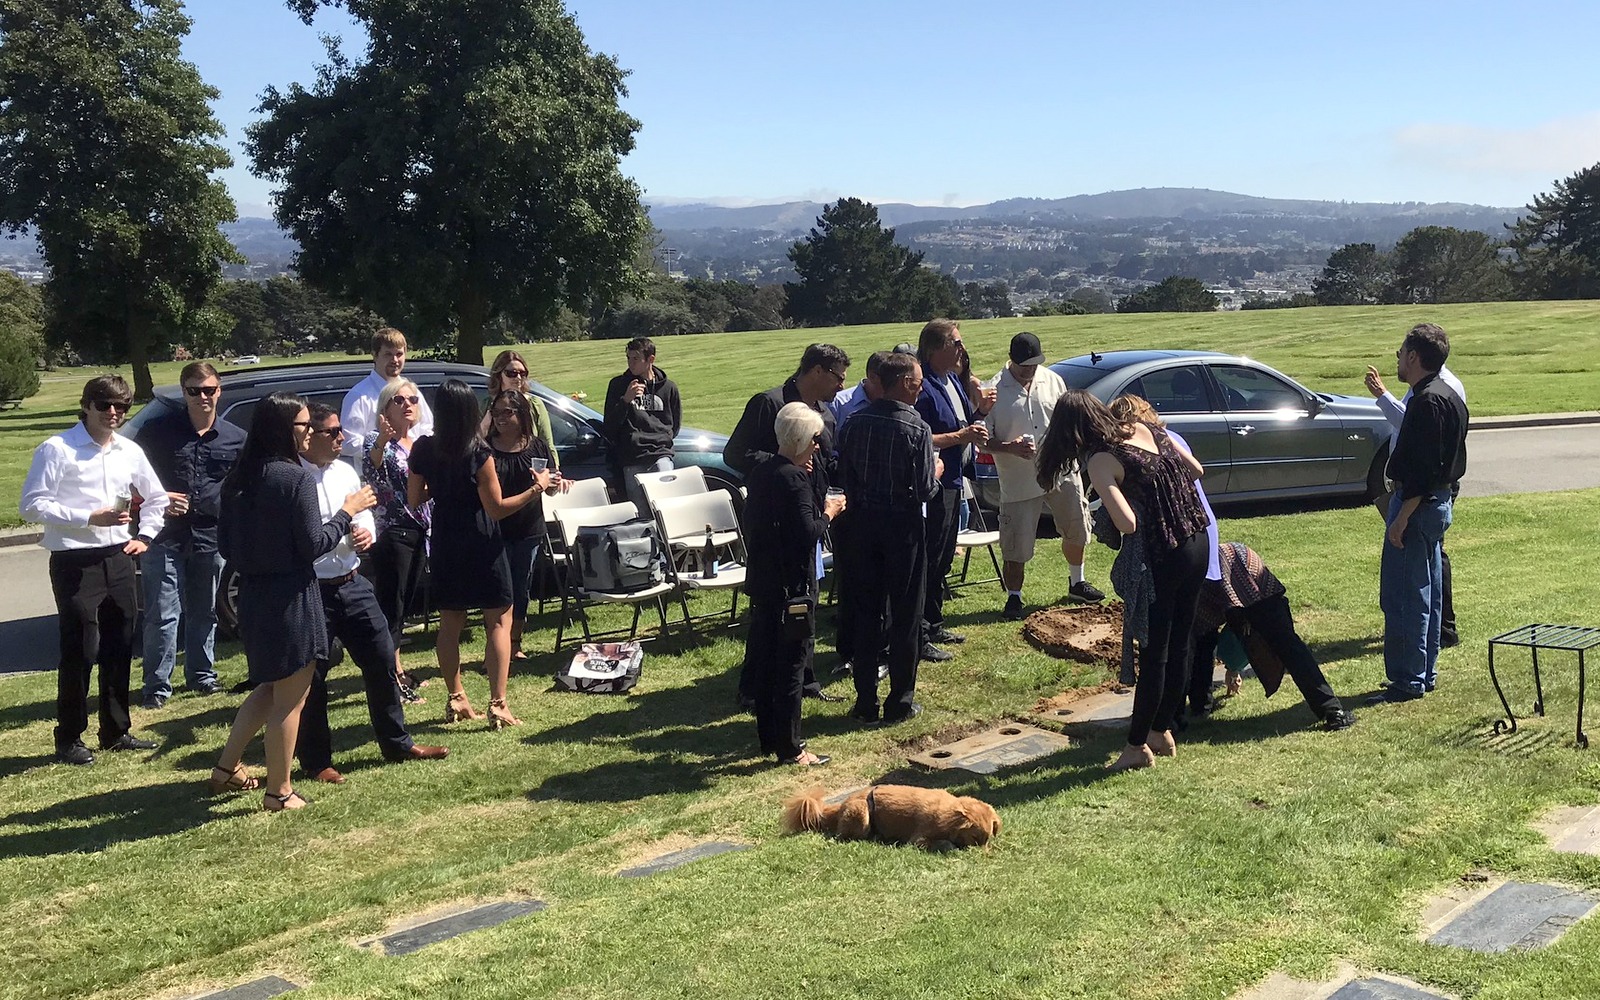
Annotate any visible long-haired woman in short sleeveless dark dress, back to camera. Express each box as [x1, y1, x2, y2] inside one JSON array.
[[406, 379, 549, 730]]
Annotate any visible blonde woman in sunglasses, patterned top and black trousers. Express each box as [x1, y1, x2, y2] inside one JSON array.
[[362, 378, 432, 702]]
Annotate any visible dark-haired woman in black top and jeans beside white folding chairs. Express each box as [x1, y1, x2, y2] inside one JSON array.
[[488, 385, 562, 659]]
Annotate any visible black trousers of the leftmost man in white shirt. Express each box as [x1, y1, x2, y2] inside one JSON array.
[[50, 546, 139, 749]]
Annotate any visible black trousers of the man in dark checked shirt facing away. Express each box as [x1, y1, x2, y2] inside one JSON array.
[[850, 504, 942, 718]]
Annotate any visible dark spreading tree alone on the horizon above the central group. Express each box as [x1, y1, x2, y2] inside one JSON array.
[[784, 198, 960, 326]]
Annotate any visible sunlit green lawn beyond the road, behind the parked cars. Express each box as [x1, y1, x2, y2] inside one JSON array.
[[0, 301, 1600, 526]]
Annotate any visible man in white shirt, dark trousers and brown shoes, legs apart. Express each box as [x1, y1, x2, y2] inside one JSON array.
[[294, 403, 450, 784]]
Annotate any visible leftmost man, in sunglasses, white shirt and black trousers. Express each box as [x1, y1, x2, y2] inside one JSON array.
[[21, 374, 168, 765]]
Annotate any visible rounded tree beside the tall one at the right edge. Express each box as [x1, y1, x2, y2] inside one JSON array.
[[1384, 226, 1510, 302]]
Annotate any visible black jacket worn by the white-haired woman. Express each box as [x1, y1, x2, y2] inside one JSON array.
[[744, 454, 827, 602]]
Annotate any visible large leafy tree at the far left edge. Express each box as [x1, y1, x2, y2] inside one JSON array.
[[0, 0, 242, 398]]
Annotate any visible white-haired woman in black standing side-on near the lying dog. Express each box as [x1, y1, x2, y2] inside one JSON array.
[[744, 403, 845, 766]]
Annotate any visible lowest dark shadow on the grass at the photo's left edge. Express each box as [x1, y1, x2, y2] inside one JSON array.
[[0, 779, 229, 858]]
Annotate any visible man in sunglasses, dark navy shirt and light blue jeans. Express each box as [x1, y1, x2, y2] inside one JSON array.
[[138, 362, 245, 709]]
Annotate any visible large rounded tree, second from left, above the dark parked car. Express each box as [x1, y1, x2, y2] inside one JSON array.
[[246, 0, 648, 363]]
